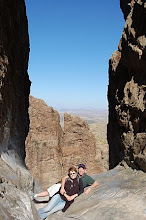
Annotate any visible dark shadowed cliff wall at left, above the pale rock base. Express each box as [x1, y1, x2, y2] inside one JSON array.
[[0, 0, 30, 160]]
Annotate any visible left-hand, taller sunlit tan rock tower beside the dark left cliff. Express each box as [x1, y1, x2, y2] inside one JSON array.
[[25, 96, 63, 189]]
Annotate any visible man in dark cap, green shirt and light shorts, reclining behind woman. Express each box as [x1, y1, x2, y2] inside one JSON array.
[[33, 164, 98, 200]]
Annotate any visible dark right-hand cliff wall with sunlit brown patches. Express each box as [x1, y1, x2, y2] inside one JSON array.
[[108, 0, 146, 172]]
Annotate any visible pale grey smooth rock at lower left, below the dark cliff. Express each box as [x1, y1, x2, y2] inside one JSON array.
[[0, 154, 40, 220]]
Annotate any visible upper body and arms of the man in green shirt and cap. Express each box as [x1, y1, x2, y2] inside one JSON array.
[[60, 164, 98, 195]]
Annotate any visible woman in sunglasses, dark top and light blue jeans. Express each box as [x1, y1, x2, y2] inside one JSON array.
[[38, 167, 84, 219]]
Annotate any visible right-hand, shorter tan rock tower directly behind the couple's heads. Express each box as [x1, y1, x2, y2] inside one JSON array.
[[62, 113, 101, 174]]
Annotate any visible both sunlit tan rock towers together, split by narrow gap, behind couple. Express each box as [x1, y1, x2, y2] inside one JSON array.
[[25, 96, 103, 189]]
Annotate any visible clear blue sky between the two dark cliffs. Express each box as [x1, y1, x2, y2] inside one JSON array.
[[25, 0, 125, 109]]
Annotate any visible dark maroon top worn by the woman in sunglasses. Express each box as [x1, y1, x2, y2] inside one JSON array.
[[59, 178, 84, 212]]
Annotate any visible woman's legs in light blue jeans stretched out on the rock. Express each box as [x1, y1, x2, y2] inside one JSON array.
[[38, 194, 63, 217]]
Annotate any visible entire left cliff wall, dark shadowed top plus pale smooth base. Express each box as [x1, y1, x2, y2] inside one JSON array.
[[0, 0, 38, 220]]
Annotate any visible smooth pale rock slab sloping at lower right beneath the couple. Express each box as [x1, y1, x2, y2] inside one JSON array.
[[37, 166, 146, 220]]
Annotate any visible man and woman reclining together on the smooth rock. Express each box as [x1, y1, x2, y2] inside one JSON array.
[[34, 164, 98, 219]]
